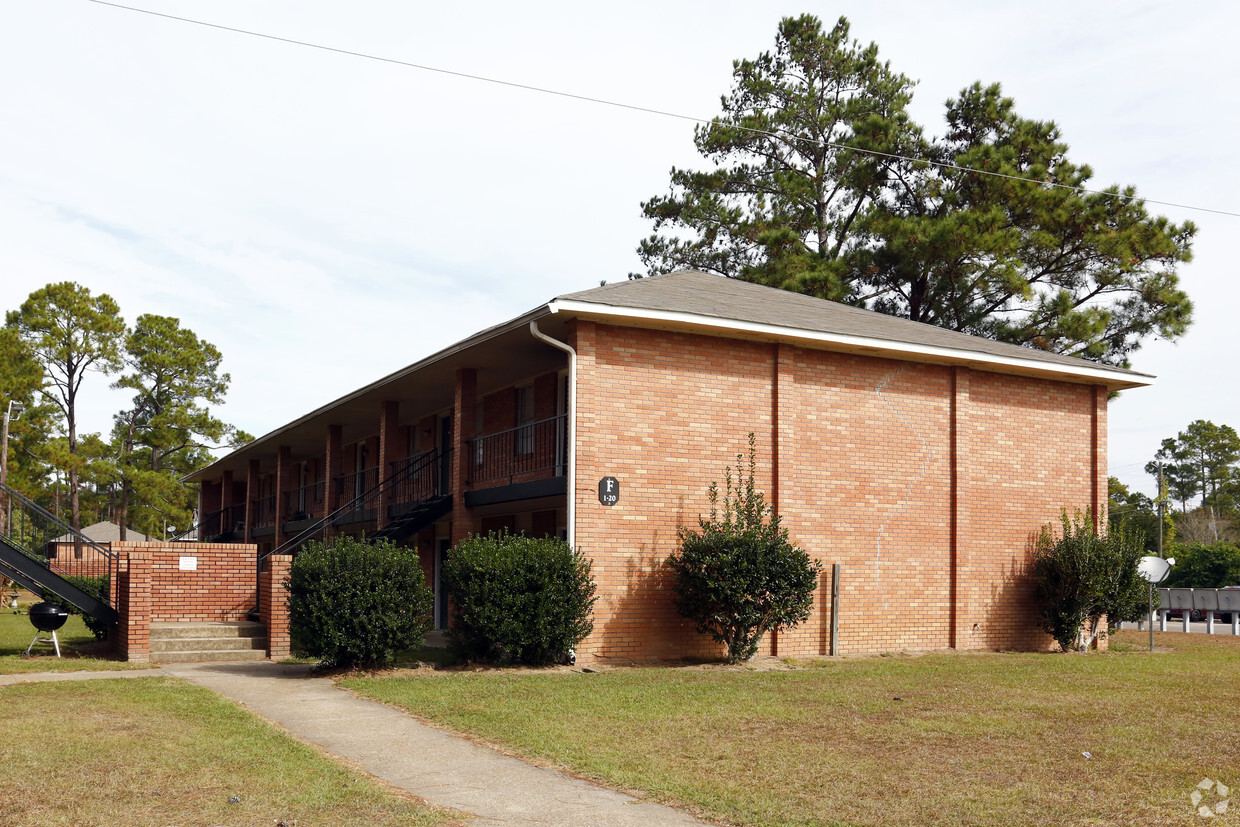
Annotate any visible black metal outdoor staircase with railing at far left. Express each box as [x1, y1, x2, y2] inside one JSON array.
[[0, 485, 119, 626]]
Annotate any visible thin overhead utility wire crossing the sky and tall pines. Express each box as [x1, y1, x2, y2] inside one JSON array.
[[87, 0, 1240, 218]]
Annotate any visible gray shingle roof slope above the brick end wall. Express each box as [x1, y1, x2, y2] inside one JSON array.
[[557, 270, 1151, 384]]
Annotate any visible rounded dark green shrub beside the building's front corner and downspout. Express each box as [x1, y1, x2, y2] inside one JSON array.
[[441, 532, 595, 665]]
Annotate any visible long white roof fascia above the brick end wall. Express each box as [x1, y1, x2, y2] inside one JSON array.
[[547, 299, 1154, 387]]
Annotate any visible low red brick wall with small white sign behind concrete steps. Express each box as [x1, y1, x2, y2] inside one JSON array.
[[112, 543, 258, 622]]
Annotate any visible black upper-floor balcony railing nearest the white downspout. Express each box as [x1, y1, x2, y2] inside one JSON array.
[[465, 414, 568, 486]]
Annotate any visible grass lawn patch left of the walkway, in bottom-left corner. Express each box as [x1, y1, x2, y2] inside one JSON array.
[[0, 677, 449, 827]]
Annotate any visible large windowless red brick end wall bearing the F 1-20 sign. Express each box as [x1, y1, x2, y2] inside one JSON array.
[[573, 322, 1106, 660]]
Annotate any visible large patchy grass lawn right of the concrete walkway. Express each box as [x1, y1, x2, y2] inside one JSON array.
[[341, 632, 1240, 825]]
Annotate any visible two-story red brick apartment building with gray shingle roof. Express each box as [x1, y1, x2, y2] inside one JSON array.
[[181, 272, 1153, 660]]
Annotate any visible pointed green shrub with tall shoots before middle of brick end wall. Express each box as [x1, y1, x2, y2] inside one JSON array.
[[667, 434, 822, 663]]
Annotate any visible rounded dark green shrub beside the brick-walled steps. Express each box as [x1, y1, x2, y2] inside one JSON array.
[[284, 537, 434, 666]]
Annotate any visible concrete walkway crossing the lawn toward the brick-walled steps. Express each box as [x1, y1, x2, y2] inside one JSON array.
[[158, 661, 706, 827]]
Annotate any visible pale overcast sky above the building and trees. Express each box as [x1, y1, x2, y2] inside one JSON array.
[[0, 0, 1240, 492]]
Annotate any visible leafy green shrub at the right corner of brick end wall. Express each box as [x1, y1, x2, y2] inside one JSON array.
[[1032, 511, 1149, 652]]
